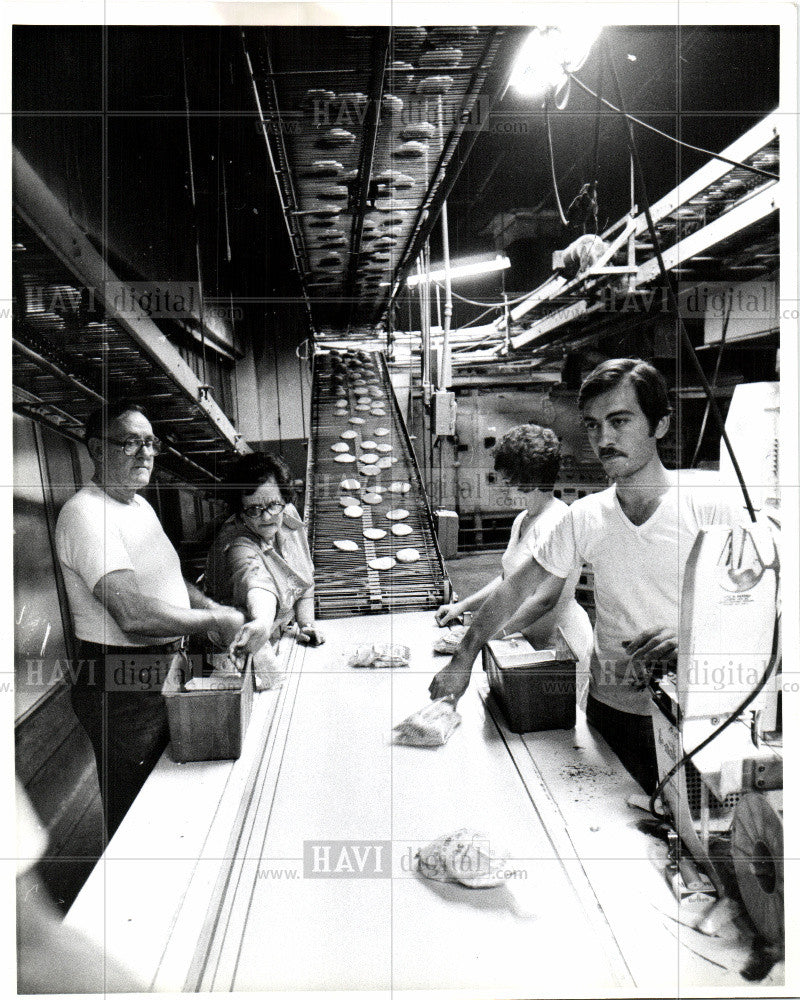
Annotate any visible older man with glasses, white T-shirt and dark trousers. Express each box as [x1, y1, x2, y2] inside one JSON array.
[[56, 400, 244, 837]]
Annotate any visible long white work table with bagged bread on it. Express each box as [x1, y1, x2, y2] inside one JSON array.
[[67, 613, 780, 998]]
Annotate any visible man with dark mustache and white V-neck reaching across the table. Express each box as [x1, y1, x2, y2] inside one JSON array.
[[430, 358, 743, 792]]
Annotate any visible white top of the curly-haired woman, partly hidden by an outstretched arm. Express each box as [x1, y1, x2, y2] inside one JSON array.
[[500, 497, 592, 669]]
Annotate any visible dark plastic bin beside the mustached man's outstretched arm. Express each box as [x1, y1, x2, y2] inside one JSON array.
[[483, 635, 577, 733]]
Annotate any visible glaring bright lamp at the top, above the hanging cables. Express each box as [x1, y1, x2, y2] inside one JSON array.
[[509, 19, 602, 97]]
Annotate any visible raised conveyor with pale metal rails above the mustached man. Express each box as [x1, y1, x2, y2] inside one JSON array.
[[428, 112, 781, 369]]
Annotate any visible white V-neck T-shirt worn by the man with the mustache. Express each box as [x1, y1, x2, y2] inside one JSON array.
[[533, 485, 743, 715]]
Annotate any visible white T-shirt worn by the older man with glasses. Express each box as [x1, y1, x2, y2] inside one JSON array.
[[56, 483, 190, 646]]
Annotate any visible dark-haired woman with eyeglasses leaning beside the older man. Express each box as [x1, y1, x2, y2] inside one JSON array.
[[205, 453, 324, 684]]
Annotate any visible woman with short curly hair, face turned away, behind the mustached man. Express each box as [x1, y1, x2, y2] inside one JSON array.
[[436, 424, 592, 667]]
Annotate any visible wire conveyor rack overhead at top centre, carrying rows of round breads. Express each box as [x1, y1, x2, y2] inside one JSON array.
[[243, 26, 524, 339]]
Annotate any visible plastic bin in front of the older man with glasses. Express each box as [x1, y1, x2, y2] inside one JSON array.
[[161, 653, 253, 763]]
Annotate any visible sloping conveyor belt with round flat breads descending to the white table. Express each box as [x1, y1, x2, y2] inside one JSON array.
[[306, 351, 449, 618]]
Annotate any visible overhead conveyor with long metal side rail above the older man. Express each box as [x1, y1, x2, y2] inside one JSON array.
[[12, 151, 250, 484]]
